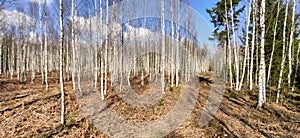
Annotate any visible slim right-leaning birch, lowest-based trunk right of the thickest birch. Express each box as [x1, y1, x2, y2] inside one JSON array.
[[276, 0, 289, 103]]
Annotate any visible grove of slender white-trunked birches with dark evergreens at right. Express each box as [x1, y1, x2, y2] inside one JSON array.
[[0, 0, 300, 124]]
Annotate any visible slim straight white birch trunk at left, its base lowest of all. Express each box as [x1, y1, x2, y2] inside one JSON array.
[[59, 0, 65, 124]]
